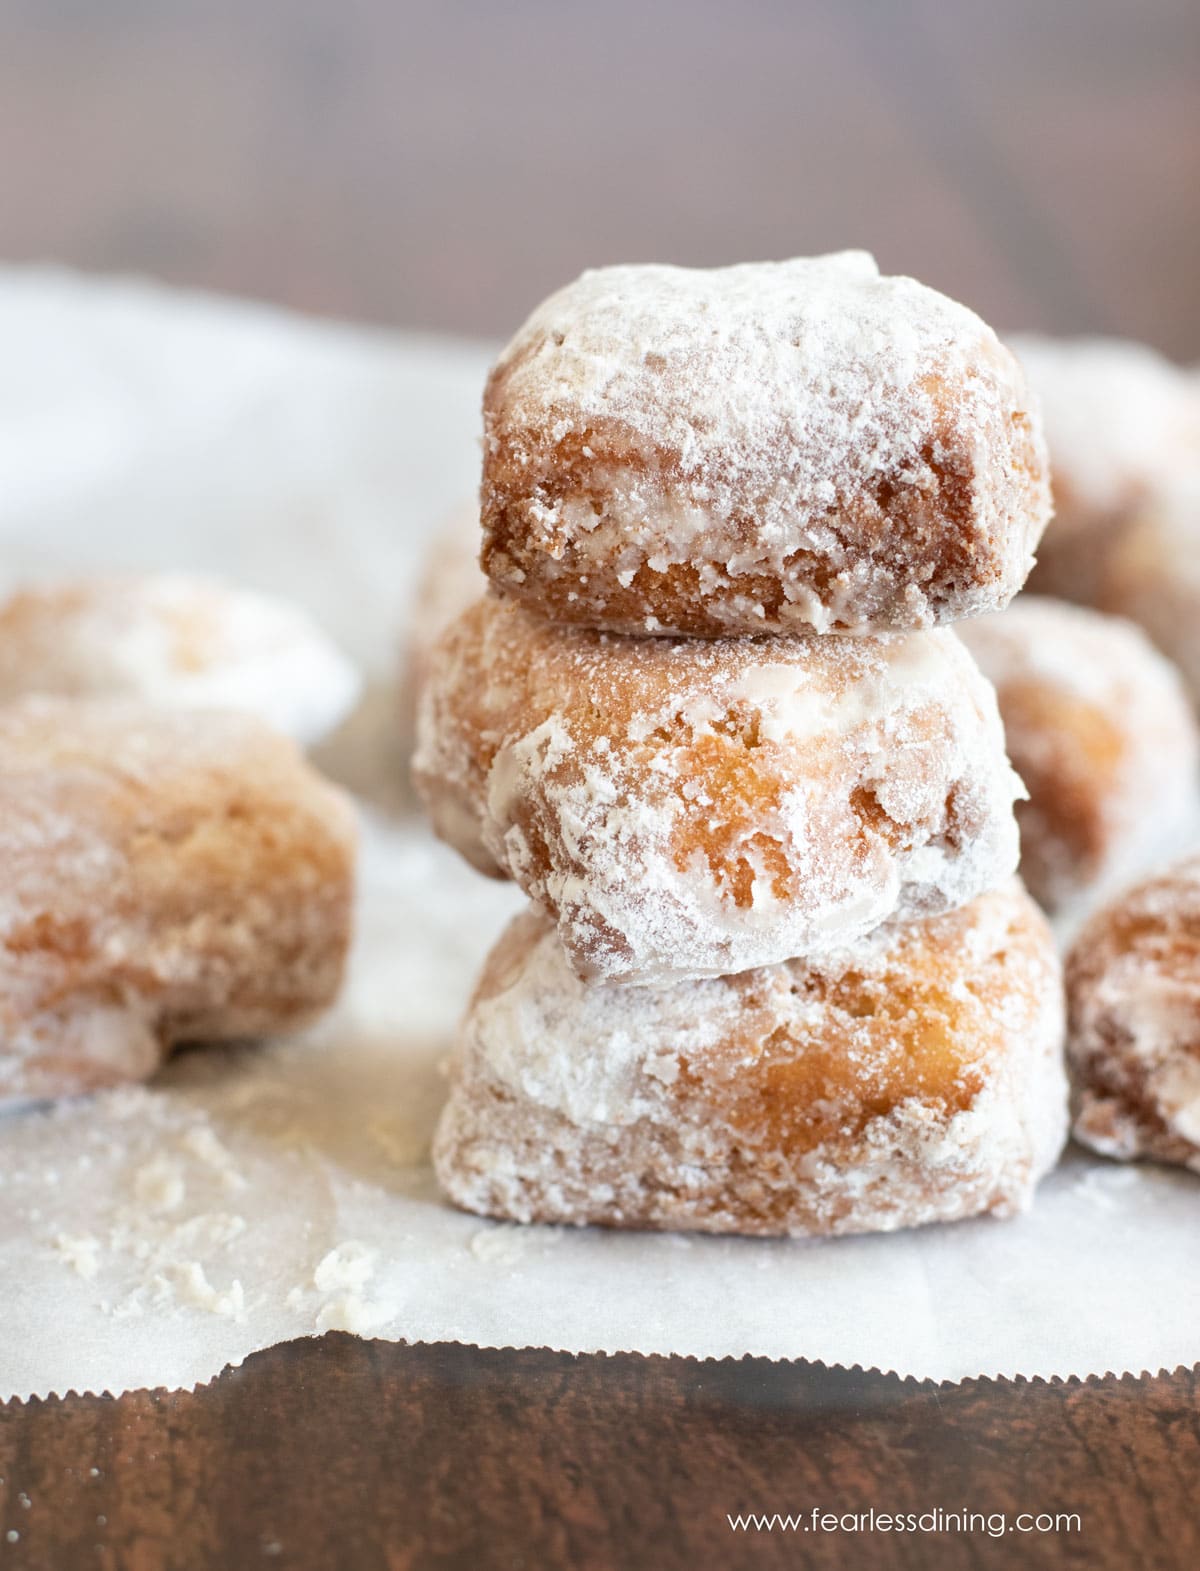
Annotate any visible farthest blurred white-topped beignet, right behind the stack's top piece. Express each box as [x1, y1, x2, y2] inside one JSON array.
[[1008, 333, 1200, 610]]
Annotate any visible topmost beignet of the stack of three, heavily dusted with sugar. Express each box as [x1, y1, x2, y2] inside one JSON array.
[[481, 251, 1049, 636]]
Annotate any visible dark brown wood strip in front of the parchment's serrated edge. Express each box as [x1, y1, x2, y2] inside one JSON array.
[[0, 1334, 1200, 1571]]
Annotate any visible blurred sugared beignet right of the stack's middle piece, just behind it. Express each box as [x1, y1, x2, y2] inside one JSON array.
[[960, 594, 1200, 911]]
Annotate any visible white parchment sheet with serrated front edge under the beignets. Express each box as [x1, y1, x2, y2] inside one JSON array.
[[0, 270, 1200, 1398]]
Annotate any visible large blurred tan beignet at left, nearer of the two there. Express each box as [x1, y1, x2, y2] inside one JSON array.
[[0, 699, 355, 1106]]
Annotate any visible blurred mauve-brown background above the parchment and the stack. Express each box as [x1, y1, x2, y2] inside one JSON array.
[[0, 0, 1200, 360]]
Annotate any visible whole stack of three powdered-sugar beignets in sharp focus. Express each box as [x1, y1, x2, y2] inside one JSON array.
[[415, 253, 1065, 1233]]
